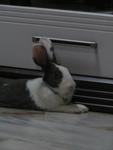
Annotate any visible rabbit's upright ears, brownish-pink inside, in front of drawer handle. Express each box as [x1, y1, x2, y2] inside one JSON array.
[[32, 38, 57, 70]]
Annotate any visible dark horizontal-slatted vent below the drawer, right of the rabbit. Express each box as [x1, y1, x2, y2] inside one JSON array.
[[73, 79, 113, 113]]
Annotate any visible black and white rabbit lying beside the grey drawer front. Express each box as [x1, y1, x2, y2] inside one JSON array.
[[0, 38, 88, 113]]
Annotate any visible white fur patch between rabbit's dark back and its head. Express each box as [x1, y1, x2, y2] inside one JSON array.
[[27, 78, 64, 109]]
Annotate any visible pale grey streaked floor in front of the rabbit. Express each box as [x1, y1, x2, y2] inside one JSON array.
[[0, 109, 113, 150]]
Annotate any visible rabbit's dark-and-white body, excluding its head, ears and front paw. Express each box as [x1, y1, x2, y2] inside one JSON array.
[[0, 78, 64, 110]]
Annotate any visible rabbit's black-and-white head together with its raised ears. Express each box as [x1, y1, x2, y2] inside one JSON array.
[[33, 38, 75, 102]]
